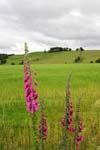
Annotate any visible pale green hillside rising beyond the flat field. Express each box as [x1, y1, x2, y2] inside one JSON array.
[[7, 50, 100, 64]]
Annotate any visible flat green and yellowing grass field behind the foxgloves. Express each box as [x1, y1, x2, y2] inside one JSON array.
[[0, 63, 100, 150]]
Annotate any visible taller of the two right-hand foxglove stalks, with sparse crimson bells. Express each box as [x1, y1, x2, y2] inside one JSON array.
[[60, 74, 75, 150]]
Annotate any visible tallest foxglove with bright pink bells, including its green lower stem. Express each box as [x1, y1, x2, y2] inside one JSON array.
[[24, 43, 39, 150]]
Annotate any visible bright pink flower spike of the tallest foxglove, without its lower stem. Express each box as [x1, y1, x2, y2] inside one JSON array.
[[24, 42, 39, 114]]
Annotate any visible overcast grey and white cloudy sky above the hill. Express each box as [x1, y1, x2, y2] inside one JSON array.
[[0, 0, 100, 54]]
